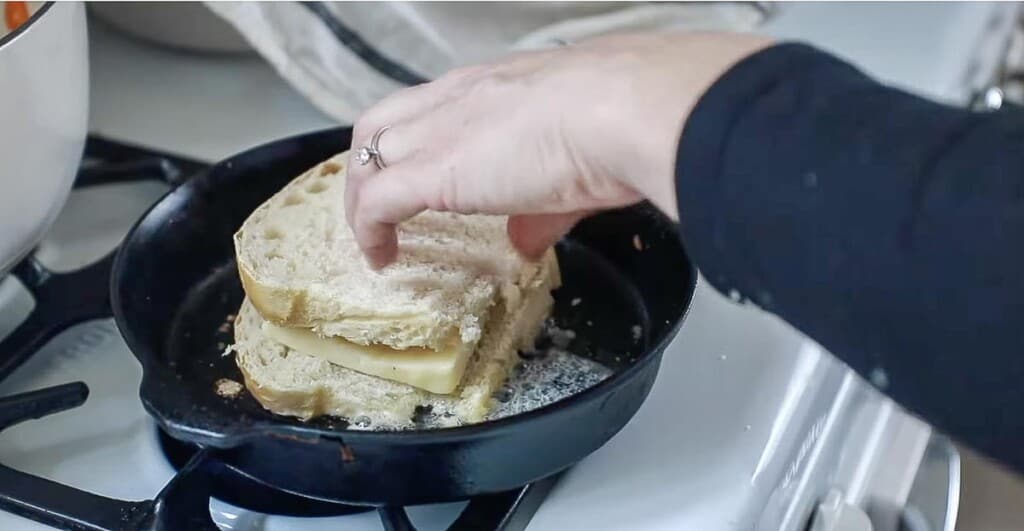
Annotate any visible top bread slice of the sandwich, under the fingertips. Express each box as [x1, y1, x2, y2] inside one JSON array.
[[234, 152, 542, 350]]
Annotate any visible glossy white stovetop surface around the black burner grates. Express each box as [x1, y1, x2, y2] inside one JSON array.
[[0, 3, 1007, 531]]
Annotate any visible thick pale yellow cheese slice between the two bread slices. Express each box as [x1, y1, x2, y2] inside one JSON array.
[[262, 321, 475, 395]]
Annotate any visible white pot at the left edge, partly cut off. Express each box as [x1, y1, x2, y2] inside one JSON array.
[[0, 2, 89, 276]]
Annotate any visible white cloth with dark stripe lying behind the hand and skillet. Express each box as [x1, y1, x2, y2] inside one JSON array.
[[207, 2, 762, 122]]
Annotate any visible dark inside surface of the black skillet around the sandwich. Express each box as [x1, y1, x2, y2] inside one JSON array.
[[112, 129, 695, 446]]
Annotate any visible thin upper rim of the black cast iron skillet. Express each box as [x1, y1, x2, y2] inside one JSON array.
[[110, 126, 698, 448]]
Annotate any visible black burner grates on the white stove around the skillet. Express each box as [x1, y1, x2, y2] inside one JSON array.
[[0, 137, 557, 531]]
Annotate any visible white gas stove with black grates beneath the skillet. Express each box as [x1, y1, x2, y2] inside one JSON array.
[[0, 3, 998, 531]]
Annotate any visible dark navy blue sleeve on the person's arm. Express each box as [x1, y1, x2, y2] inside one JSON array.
[[676, 44, 1024, 471]]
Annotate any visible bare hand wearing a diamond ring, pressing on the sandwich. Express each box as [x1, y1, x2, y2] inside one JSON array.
[[345, 34, 769, 267]]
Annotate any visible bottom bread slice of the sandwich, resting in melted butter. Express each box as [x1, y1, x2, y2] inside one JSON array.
[[232, 257, 558, 429]]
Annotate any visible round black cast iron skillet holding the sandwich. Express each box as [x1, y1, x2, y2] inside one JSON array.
[[111, 128, 696, 505]]
